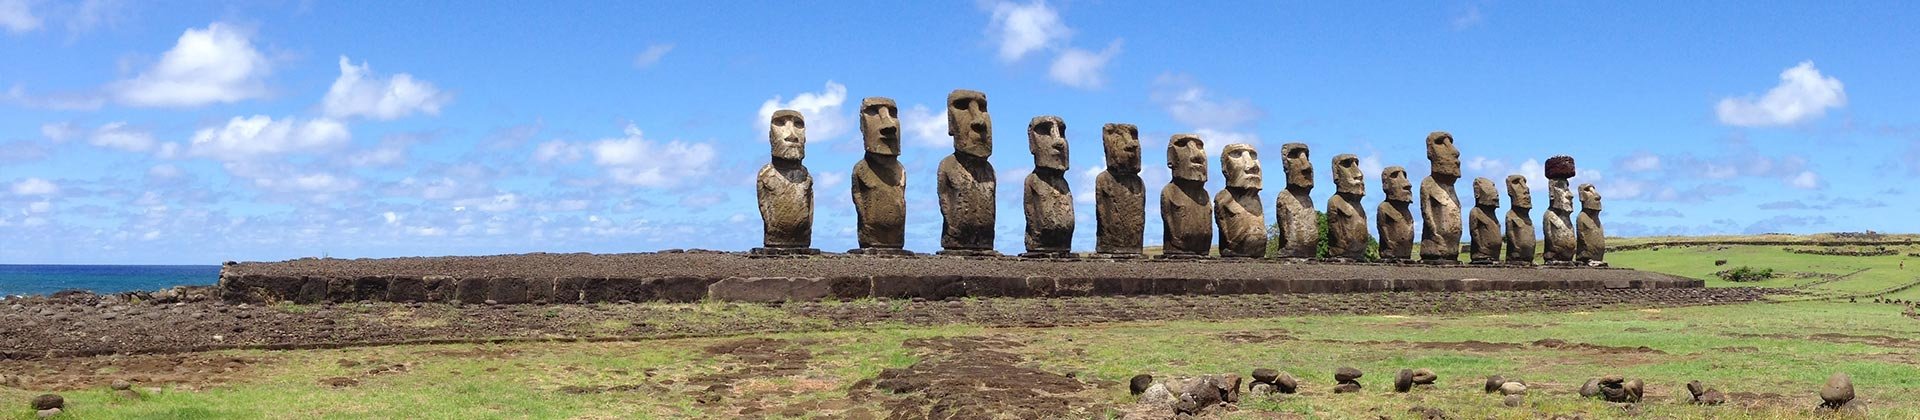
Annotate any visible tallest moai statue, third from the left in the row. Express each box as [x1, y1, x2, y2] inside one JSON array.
[[935, 90, 1000, 257]]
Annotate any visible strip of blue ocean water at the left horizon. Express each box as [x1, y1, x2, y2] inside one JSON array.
[[0, 265, 221, 295]]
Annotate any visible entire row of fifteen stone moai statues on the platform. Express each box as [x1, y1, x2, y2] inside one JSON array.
[[755, 90, 1605, 263]]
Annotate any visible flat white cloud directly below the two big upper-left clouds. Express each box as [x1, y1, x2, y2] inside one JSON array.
[[192, 115, 351, 159]]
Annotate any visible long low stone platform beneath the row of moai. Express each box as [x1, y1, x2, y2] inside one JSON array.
[[219, 251, 1703, 303]]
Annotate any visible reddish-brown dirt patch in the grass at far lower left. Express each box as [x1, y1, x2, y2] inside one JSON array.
[[0, 355, 267, 391]]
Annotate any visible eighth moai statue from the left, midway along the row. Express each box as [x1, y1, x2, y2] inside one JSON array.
[[1273, 144, 1319, 259]]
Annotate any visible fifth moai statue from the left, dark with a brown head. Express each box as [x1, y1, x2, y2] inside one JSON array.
[[1092, 125, 1146, 257]]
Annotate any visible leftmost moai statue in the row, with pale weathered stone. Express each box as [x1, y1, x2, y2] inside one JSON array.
[[753, 109, 820, 255]]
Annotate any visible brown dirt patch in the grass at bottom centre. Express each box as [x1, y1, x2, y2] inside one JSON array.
[[872, 338, 1100, 418]]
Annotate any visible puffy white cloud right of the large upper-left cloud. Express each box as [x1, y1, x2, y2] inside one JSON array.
[[321, 56, 453, 119]]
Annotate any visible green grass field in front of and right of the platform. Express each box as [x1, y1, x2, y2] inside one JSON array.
[[0, 245, 1920, 418]]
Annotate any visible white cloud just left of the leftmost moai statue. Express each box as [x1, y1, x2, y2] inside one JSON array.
[[589, 125, 716, 188]]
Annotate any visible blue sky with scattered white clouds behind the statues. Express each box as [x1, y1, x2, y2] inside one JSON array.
[[0, 0, 1920, 263]]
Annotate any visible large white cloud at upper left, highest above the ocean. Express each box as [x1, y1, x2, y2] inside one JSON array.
[[109, 23, 273, 107]]
